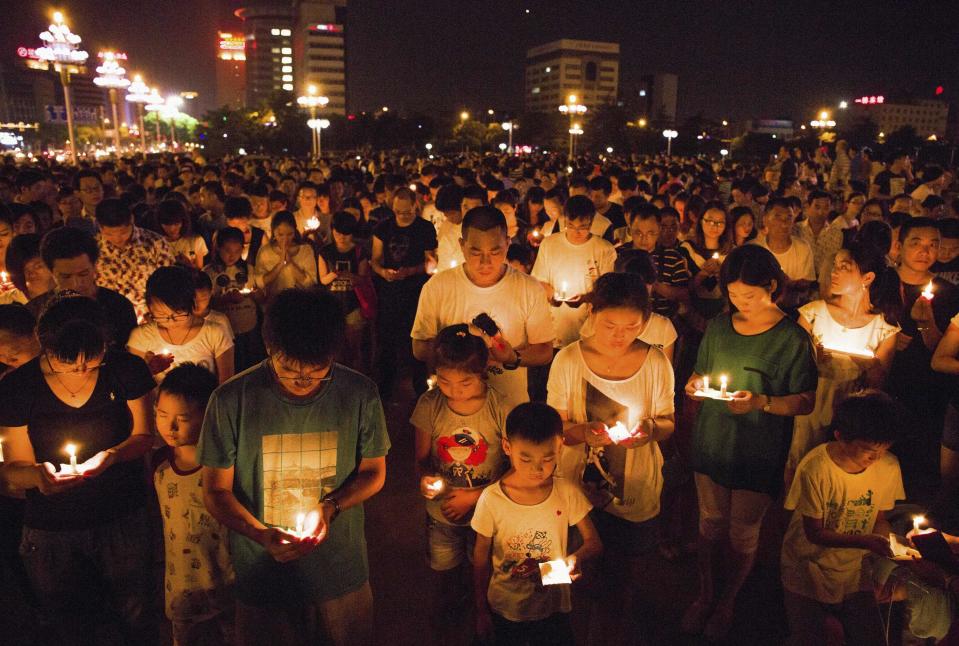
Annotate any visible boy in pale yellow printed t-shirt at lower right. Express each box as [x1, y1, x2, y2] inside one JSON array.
[[782, 390, 905, 644]]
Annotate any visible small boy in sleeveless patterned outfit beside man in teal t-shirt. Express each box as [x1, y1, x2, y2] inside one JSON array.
[[152, 363, 234, 646]]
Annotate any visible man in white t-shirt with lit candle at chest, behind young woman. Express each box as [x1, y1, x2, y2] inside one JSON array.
[[531, 195, 616, 348]]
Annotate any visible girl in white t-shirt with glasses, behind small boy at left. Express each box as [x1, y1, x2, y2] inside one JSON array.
[[127, 266, 233, 383]]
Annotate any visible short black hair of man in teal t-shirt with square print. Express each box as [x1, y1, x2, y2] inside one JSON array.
[[263, 288, 345, 366]]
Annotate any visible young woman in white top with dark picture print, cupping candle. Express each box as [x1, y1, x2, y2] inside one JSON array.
[[547, 274, 674, 644]]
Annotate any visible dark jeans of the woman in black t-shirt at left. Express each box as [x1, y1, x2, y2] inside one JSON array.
[[20, 509, 162, 646]]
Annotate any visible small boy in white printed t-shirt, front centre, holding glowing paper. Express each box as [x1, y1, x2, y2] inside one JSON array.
[[470, 403, 603, 646]]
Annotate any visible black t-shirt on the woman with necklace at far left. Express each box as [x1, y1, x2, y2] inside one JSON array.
[[0, 350, 156, 531]]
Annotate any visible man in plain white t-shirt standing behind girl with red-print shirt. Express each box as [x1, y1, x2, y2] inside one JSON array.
[[410, 206, 553, 402]]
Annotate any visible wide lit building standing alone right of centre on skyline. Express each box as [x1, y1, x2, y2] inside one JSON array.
[[524, 38, 619, 112]]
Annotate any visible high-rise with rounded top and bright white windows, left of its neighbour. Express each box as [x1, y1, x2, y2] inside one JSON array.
[[234, 0, 294, 107]]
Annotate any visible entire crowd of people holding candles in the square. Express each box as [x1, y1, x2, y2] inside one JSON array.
[[0, 142, 959, 646]]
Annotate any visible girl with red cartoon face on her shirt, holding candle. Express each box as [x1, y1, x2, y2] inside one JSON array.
[[410, 324, 509, 630]]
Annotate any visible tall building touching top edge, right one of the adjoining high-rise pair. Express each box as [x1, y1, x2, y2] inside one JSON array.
[[293, 0, 346, 114]]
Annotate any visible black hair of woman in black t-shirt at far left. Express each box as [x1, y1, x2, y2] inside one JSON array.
[[37, 294, 108, 363]]
